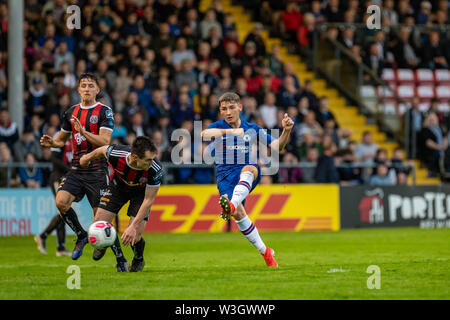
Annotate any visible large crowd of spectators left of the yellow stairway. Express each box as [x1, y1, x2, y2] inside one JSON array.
[[0, 0, 428, 188]]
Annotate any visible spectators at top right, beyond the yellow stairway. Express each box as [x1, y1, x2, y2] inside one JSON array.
[[251, 0, 450, 73]]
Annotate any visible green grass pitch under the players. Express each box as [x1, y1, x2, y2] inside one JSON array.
[[0, 228, 450, 300]]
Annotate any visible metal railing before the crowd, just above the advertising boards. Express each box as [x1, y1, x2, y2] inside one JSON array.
[[0, 162, 416, 188]]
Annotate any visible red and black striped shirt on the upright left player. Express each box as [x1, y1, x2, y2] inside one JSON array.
[[61, 102, 114, 172]]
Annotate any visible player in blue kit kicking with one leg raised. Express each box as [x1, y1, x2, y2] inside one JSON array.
[[201, 92, 294, 267]]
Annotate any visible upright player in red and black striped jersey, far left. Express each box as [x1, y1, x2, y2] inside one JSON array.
[[41, 73, 114, 260]]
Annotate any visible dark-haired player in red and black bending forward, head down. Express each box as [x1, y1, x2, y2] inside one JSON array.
[[80, 136, 163, 272]]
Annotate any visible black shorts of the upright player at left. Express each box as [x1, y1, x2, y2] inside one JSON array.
[[58, 171, 109, 208]]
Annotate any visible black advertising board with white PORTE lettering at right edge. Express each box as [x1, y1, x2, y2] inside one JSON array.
[[339, 185, 450, 229]]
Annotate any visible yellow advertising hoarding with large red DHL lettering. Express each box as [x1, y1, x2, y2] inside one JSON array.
[[120, 185, 339, 233]]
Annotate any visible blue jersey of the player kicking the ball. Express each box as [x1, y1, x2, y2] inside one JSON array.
[[208, 119, 275, 180]]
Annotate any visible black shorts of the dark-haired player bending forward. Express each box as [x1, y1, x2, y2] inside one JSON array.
[[99, 184, 148, 221]]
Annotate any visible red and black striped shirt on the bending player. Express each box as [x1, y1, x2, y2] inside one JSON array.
[[106, 144, 163, 189]]
